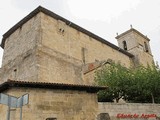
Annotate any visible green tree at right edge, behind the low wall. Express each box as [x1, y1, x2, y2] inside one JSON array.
[[128, 66, 160, 103]]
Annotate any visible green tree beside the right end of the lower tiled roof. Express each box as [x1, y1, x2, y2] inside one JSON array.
[[95, 63, 131, 102]]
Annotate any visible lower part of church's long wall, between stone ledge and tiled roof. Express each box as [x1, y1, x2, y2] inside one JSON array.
[[37, 47, 85, 84]]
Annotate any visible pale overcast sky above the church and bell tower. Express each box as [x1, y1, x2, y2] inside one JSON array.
[[0, 0, 160, 64]]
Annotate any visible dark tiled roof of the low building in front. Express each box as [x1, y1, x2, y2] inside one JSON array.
[[0, 80, 107, 93]]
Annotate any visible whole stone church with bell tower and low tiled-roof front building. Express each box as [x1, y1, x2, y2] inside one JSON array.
[[0, 6, 153, 120]]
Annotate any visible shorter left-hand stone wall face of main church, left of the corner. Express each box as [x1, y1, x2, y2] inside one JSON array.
[[0, 14, 41, 83]]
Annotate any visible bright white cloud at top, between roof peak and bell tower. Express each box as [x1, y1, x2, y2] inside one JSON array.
[[68, 0, 140, 21]]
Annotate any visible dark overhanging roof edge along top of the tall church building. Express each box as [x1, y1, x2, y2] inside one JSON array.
[[1, 6, 134, 57]]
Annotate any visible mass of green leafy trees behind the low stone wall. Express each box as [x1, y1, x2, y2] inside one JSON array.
[[95, 63, 160, 103]]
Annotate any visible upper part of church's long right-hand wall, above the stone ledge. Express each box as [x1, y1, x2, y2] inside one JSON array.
[[41, 13, 131, 67]]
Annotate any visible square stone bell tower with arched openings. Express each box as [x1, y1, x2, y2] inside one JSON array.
[[116, 27, 154, 66]]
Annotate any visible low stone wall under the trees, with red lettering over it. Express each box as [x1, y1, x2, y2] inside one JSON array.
[[98, 102, 160, 120]]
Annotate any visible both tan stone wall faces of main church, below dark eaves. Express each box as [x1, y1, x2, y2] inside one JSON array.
[[0, 12, 132, 84]]
